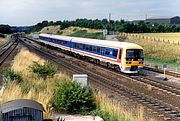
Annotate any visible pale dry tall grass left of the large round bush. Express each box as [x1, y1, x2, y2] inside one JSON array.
[[0, 48, 69, 118]]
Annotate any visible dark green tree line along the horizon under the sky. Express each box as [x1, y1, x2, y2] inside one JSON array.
[[0, 19, 180, 34]]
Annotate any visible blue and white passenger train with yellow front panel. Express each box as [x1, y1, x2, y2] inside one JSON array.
[[36, 34, 144, 74]]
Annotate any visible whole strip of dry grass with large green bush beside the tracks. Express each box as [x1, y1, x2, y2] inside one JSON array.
[[0, 48, 143, 121]]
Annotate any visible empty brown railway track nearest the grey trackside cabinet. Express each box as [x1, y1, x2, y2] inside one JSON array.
[[21, 37, 180, 120]]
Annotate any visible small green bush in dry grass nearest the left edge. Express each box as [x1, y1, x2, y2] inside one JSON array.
[[3, 69, 22, 85]]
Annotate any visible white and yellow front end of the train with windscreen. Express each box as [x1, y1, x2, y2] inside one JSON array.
[[121, 45, 144, 73]]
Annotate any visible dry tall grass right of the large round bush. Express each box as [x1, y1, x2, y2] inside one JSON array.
[[95, 92, 152, 121]]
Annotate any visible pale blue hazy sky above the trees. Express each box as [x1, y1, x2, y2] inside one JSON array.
[[0, 0, 180, 26]]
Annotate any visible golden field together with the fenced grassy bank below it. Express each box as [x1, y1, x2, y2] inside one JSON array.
[[119, 33, 180, 70]]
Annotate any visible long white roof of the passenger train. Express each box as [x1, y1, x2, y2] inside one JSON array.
[[40, 34, 143, 49]]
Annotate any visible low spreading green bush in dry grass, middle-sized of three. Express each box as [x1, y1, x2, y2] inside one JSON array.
[[29, 62, 57, 79]]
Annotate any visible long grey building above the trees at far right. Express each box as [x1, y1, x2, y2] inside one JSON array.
[[145, 16, 180, 24]]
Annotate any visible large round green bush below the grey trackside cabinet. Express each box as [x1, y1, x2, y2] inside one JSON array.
[[53, 81, 95, 113]]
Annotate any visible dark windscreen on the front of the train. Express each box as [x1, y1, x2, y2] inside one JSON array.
[[126, 49, 144, 59]]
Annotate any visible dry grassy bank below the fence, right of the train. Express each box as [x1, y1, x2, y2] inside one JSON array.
[[119, 35, 180, 70]]
